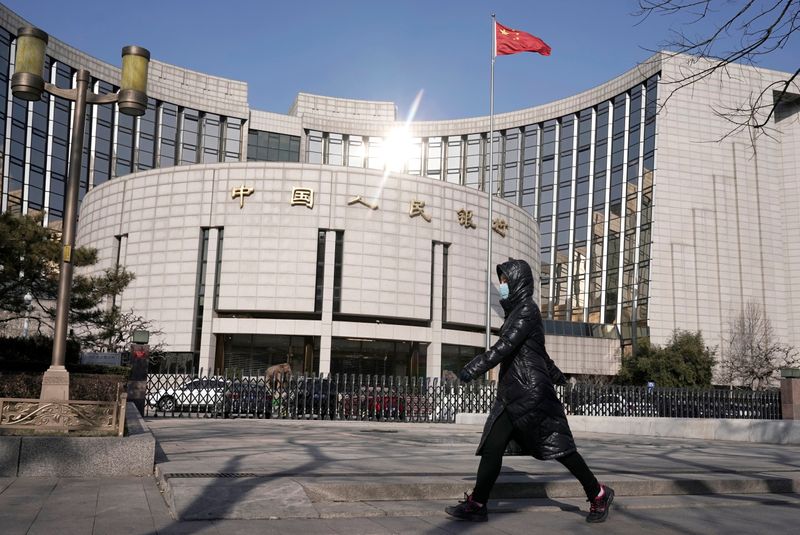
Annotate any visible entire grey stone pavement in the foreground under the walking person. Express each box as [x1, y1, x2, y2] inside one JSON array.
[[0, 418, 800, 535]]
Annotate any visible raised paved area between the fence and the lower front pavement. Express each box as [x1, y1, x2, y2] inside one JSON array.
[[149, 419, 800, 520]]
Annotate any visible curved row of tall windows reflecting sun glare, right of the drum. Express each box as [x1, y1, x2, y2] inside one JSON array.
[[306, 76, 658, 330]]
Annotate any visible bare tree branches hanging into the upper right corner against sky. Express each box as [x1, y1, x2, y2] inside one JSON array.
[[635, 0, 800, 139]]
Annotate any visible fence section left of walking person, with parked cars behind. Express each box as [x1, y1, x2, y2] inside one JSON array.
[[145, 372, 496, 422]]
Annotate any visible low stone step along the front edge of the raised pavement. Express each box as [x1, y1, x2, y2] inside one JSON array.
[[156, 466, 800, 520]]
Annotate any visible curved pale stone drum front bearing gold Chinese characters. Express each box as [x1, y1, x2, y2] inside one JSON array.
[[80, 163, 538, 376]]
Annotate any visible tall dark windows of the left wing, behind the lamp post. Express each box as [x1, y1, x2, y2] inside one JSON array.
[[0, 29, 243, 224]]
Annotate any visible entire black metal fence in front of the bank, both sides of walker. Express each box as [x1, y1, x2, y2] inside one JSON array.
[[145, 372, 781, 423]]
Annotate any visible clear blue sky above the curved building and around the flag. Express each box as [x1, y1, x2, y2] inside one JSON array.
[[3, 0, 800, 120]]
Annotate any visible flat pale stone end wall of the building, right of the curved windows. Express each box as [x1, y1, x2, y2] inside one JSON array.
[[649, 57, 800, 372]]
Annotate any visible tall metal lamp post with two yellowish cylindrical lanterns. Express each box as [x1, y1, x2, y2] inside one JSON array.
[[11, 26, 150, 400]]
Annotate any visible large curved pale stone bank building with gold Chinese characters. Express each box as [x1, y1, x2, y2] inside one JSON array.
[[0, 3, 800, 377]]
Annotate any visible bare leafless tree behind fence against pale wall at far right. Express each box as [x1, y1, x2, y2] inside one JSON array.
[[720, 302, 799, 390]]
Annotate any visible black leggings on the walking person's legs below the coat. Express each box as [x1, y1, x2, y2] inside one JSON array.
[[472, 411, 600, 503]]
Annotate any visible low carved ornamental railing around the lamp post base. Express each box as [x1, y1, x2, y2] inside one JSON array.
[[0, 385, 128, 436]]
